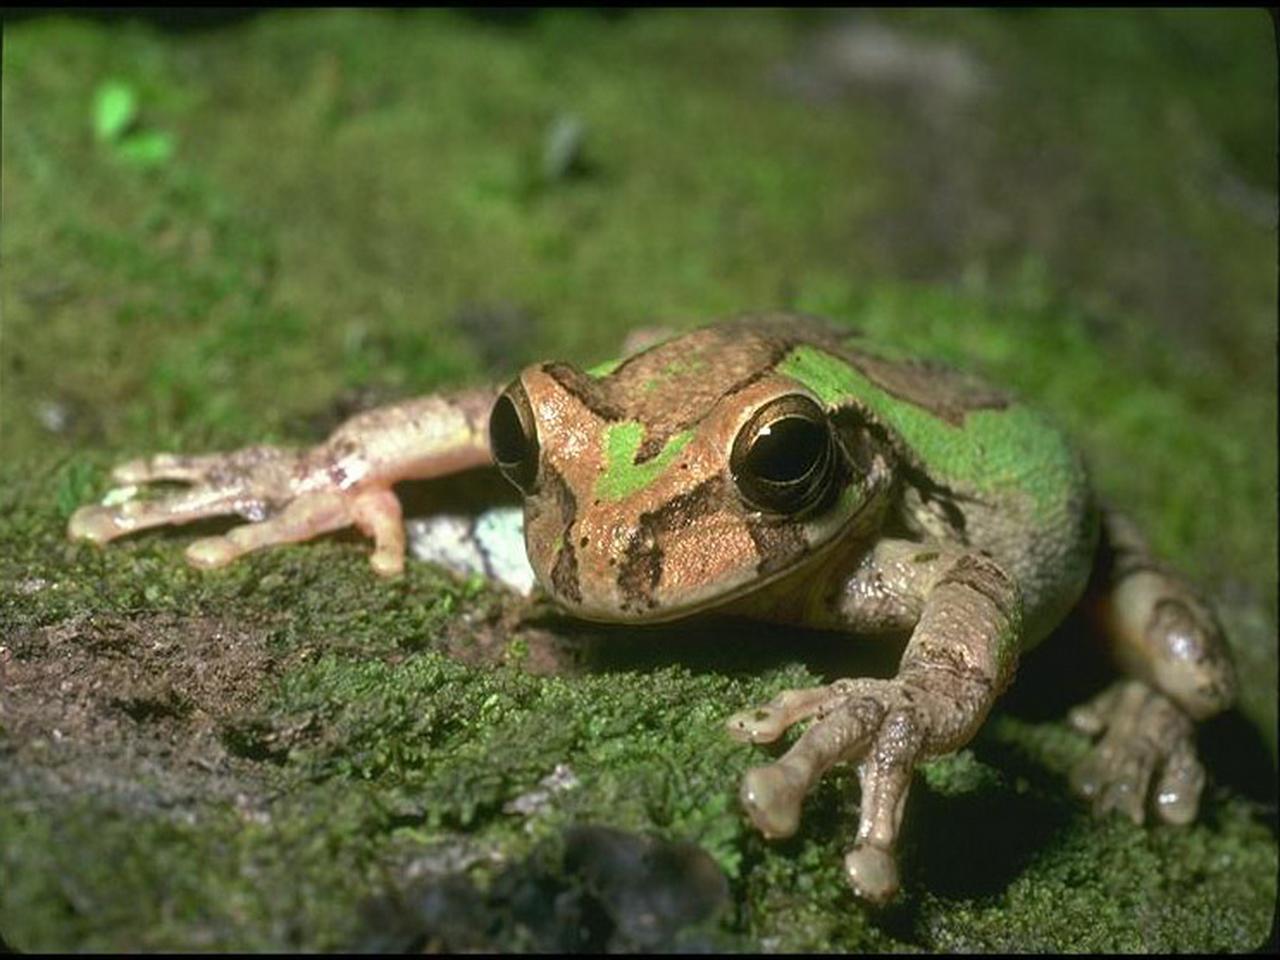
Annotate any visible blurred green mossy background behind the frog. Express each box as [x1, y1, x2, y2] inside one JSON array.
[[0, 9, 1277, 947]]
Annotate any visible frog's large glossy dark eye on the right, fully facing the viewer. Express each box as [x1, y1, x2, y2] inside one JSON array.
[[730, 394, 837, 513]]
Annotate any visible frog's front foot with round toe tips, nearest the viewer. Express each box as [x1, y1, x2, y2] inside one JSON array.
[[728, 678, 937, 904]]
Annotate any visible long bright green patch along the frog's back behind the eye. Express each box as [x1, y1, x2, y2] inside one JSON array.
[[778, 347, 1085, 517]]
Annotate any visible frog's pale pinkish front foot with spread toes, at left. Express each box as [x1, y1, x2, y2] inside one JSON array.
[[67, 447, 404, 575]]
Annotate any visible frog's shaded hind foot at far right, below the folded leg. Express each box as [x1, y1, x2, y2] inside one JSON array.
[[1069, 680, 1204, 824]]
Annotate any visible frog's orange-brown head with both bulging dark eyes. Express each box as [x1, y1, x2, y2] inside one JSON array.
[[489, 328, 869, 621]]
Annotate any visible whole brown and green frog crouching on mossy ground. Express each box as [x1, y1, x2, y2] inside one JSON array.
[[68, 317, 1236, 905]]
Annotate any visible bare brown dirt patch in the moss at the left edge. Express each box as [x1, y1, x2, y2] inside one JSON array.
[[0, 613, 279, 812]]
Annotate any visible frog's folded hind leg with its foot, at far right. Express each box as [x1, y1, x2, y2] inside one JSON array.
[[1069, 512, 1235, 823]]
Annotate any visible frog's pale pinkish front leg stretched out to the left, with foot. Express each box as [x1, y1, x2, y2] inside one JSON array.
[[67, 390, 497, 576]]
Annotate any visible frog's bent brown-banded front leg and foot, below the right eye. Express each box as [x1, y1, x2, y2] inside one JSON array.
[[730, 540, 1021, 902]]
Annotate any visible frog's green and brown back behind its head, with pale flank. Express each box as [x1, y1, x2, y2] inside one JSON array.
[[757, 321, 1097, 643]]
